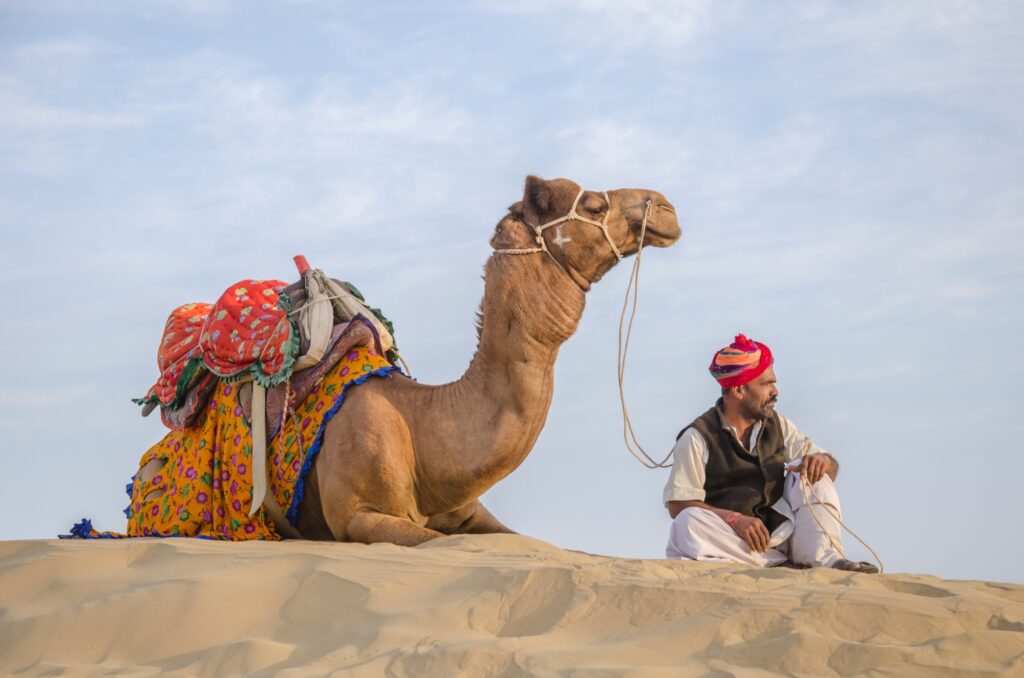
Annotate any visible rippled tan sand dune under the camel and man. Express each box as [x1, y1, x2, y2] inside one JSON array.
[[0, 536, 1024, 676]]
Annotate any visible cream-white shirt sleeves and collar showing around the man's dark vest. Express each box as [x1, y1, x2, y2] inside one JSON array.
[[663, 415, 828, 504]]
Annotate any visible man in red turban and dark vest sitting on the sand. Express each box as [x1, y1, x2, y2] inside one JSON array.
[[665, 334, 879, 573]]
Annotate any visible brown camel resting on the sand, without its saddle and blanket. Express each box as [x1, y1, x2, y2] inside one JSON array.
[[296, 176, 681, 546]]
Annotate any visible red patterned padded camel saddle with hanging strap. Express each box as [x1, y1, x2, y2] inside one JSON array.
[[135, 256, 400, 536]]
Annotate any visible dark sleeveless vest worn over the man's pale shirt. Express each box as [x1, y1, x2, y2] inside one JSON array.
[[676, 398, 785, 532]]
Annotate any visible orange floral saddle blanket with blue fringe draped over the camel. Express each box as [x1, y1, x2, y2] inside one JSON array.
[[71, 346, 397, 541]]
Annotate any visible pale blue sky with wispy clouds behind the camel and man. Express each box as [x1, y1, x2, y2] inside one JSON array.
[[0, 0, 1024, 583]]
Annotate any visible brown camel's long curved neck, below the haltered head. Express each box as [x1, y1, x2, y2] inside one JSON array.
[[423, 249, 584, 499]]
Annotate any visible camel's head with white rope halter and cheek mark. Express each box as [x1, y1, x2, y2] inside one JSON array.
[[492, 176, 681, 290]]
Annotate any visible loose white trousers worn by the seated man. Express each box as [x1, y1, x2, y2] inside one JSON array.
[[665, 473, 844, 567]]
